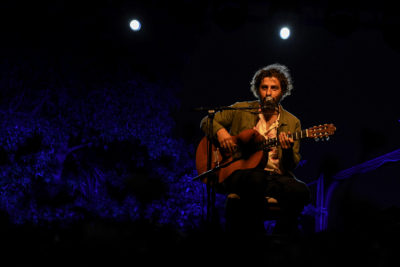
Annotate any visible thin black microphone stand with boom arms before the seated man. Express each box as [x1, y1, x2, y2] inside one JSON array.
[[192, 106, 260, 230]]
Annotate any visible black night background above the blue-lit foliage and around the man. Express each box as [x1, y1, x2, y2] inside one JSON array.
[[0, 0, 400, 266]]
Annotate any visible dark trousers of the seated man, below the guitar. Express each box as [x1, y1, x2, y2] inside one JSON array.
[[224, 169, 310, 237]]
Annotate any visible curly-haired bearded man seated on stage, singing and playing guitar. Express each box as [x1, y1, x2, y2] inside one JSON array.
[[200, 64, 310, 239]]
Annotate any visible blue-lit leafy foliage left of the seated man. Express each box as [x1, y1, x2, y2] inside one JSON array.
[[0, 59, 212, 231]]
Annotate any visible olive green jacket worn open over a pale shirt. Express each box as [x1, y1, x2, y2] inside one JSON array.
[[200, 101, 301, 175]]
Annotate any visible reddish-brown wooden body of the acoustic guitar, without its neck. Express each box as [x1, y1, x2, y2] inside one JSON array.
[[196, 129, 267, 183]]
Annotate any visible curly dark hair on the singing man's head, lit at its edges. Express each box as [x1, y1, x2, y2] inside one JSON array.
[[250, 63, 293, 100]]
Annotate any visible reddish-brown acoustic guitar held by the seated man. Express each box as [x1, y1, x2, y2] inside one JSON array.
[[196, 124, 336, 183]]
